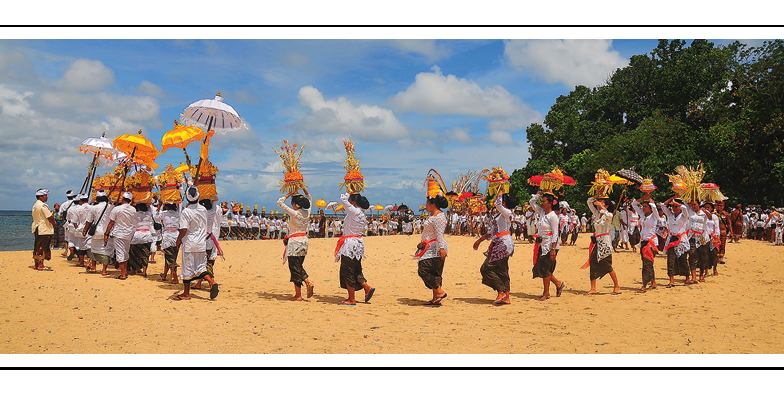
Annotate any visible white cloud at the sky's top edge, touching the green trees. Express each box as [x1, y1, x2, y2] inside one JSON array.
[[504, 40, 629, 87]]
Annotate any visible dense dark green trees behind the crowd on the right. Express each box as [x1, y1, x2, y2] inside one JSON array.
[[511, 40, 784, 217]]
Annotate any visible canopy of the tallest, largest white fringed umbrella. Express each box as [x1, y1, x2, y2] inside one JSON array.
[[180, 93, 247, 134]]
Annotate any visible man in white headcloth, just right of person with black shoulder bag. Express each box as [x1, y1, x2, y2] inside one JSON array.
[[103, 192, 136, 280]]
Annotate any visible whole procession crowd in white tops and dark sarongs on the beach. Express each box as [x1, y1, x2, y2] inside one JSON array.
[[32, 187, 772, 305]]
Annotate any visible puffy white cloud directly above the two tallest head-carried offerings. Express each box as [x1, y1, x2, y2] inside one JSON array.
[[295, 86, 409, 141]]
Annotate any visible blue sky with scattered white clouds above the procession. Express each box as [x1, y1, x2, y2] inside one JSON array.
[[0, 35, 764, 210]]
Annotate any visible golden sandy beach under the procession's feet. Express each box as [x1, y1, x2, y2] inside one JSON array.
[[0, 234, 784, 354]]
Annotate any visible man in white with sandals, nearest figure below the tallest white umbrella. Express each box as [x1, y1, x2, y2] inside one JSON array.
[[174, 187, 218, 300]]
